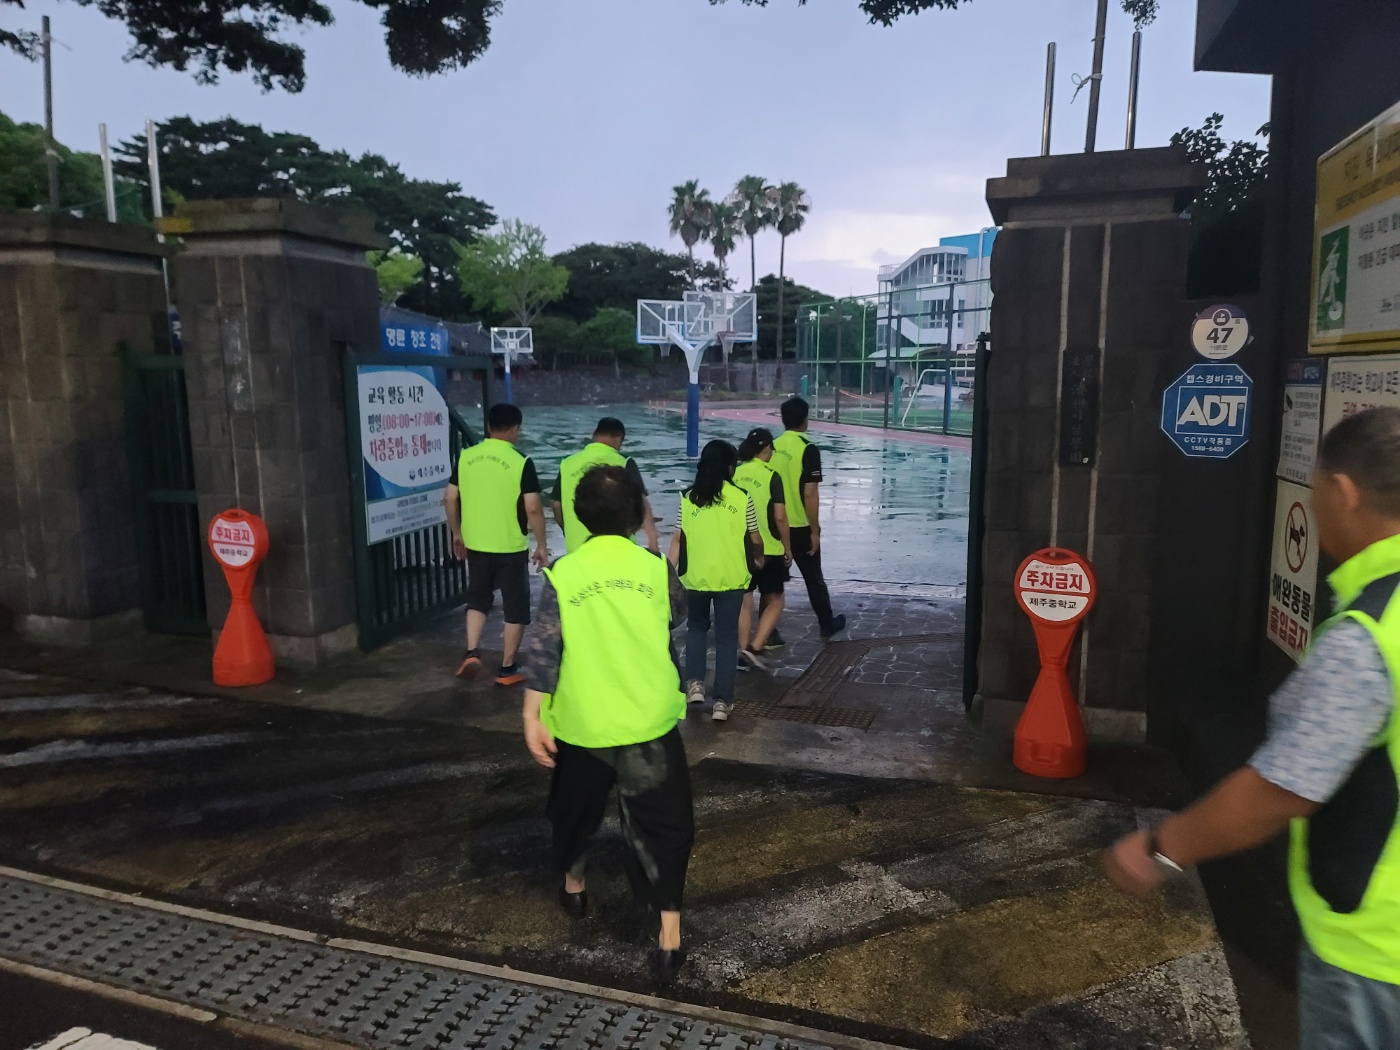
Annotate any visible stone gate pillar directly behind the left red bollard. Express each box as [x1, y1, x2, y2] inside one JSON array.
[[167, 199, 386, 662]]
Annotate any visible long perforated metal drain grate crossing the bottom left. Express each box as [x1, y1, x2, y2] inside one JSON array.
[[0, 876, 829, 1050]]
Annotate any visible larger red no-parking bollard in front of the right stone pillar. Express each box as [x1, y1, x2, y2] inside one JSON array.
[[1014, 547, 1098, 778]]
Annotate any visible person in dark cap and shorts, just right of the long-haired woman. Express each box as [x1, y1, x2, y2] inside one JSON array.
[[734, 427, 792, 671]]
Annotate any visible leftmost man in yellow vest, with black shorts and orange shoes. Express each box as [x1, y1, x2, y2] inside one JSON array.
[[445, 405, 549, 686]]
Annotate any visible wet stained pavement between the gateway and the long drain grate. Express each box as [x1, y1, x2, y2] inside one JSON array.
[[0, 675, 1242, 1050]]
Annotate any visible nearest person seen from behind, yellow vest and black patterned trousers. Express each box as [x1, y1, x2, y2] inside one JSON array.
[[524, 466, 694, 986]]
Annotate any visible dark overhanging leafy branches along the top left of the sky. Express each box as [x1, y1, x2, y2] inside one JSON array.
[[0, 0, 501, 91]]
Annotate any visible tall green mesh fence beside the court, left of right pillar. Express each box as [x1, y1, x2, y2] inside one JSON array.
[[797, 280, 991, 434]]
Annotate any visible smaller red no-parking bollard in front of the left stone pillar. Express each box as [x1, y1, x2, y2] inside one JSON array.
[[209, 511, 274, 686]]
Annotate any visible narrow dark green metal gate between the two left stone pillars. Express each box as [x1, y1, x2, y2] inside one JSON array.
[[122, 353, 209, 634]]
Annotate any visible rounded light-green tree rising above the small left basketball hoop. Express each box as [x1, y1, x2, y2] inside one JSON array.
[[456, 218, 568, 326]]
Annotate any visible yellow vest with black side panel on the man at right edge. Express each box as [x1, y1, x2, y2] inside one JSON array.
[[1288, 536, 1400, 984]]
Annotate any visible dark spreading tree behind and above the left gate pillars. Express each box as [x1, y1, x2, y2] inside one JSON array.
[[116, 116, 496, 321]]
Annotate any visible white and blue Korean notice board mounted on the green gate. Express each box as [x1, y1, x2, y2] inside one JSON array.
[[357, 365, 452, 543]]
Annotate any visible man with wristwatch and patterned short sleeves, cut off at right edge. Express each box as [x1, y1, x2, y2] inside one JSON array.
[[1105, 407, 1400, 1050]]
